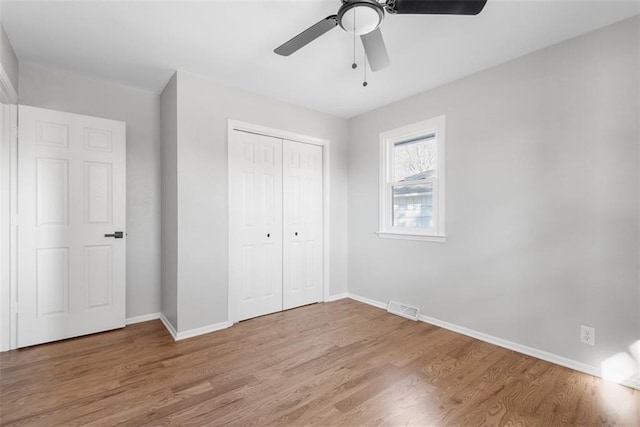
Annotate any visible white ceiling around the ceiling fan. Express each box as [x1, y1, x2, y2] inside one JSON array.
[[0, 0, 640, 118]]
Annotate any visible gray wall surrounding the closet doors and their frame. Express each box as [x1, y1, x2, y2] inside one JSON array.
[[169, 71, 348, 332]]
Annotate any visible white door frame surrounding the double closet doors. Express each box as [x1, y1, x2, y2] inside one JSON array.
[[227, 119, 331, 324]]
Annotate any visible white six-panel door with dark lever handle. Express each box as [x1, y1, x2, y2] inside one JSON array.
[[18, 106, 125, 347]]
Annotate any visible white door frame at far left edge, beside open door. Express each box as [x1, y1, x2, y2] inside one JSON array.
[[0, 64, 18, 351]]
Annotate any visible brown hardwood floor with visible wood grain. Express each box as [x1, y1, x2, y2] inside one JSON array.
[[0, 300, 640, 426]]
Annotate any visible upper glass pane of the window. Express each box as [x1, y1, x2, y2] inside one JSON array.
[[393, 135, 437, 182]]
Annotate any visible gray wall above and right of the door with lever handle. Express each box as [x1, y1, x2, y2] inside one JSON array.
[[19, 63, 160, 317]]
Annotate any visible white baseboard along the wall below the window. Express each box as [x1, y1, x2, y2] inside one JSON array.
[[349, 293, 640, 390]]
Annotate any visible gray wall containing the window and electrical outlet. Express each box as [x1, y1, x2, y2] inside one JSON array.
[[348, 17, 640, 367]]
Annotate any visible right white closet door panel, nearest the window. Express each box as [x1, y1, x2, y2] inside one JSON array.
[[282, 140, 323, 310]]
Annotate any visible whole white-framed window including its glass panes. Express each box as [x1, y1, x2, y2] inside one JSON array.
[[378, 116, 445, 242]]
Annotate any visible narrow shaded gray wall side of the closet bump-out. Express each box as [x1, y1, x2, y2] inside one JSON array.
[[160, 74, 178, 330]]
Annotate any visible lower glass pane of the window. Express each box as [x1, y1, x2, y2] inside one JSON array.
[[393, 183, 433, 228]]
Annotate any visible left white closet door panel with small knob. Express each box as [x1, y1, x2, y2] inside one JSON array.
[[229, 131, 282, 321]]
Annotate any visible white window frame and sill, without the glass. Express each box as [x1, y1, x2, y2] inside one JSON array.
[[377, 115, 446, 243]]
